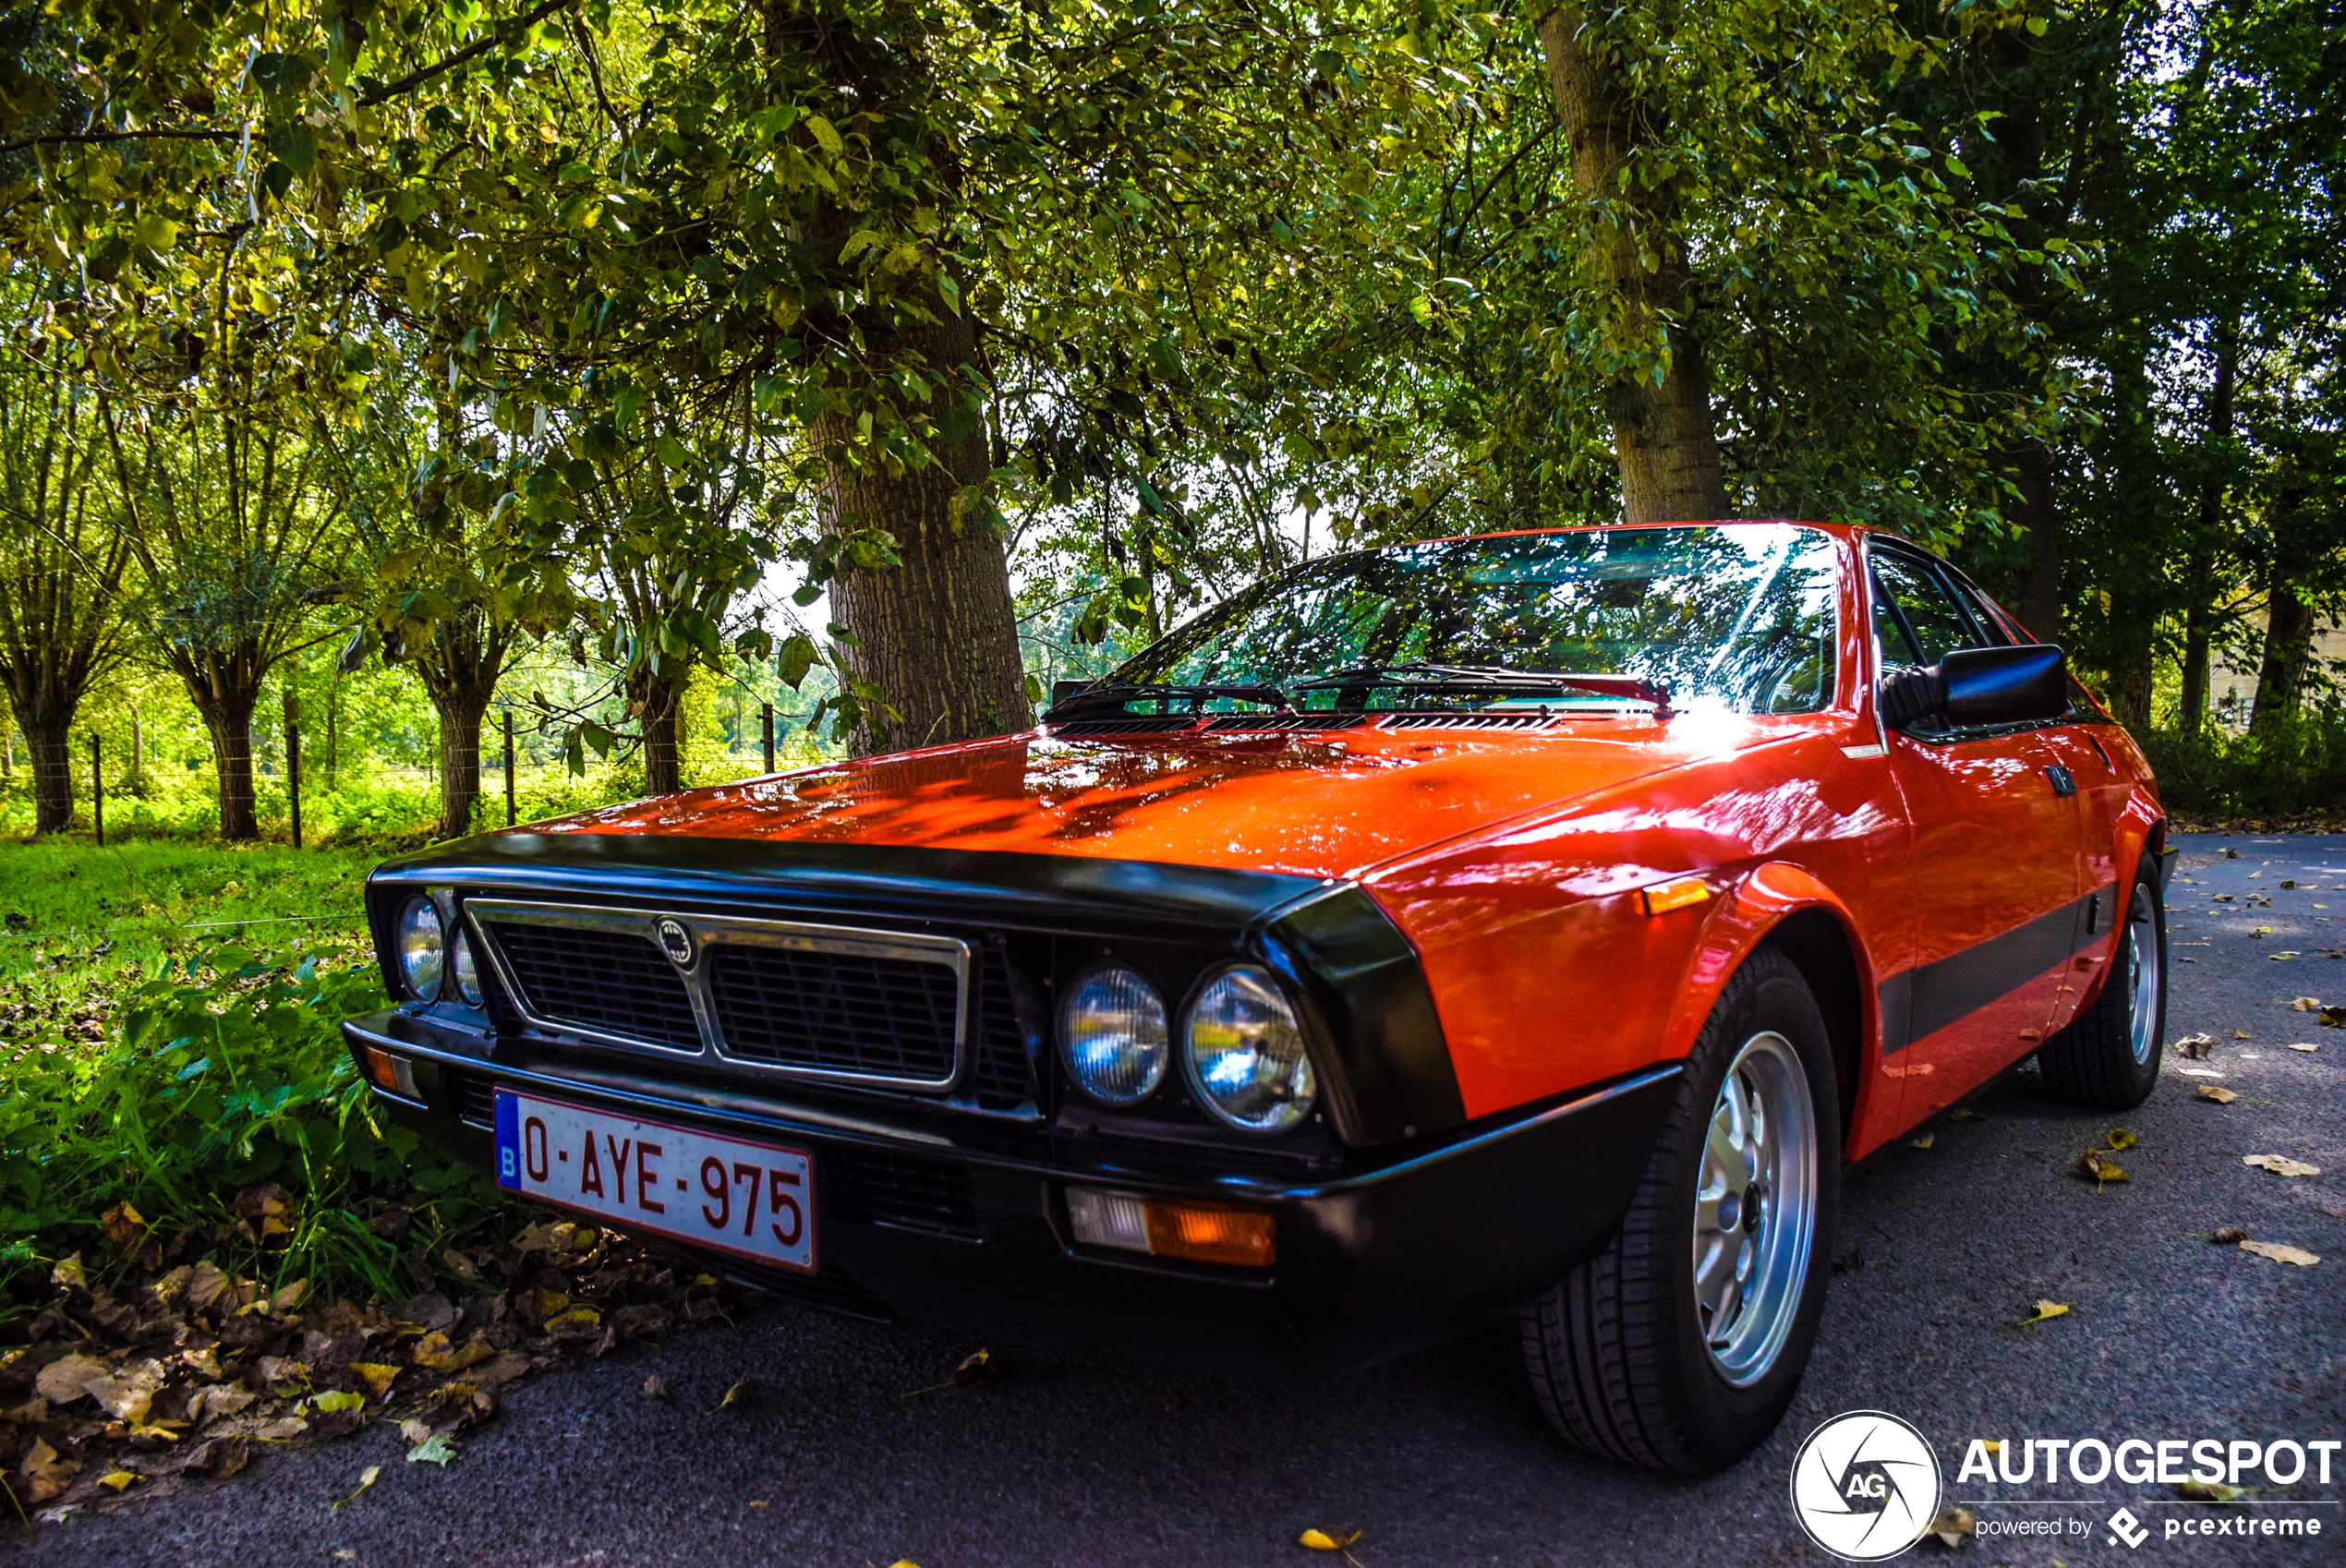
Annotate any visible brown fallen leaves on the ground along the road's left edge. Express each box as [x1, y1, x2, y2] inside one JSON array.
[[0, 1209, 739, 1510]]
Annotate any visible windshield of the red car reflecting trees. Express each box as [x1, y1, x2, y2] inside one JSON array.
[[1107, 523, 1834, 713]]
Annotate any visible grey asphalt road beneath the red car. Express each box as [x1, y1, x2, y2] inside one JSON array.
[[0, 837, 2346, 1568]]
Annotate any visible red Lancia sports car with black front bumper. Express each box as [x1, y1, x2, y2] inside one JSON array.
[[347, 523, 2171, 1472]]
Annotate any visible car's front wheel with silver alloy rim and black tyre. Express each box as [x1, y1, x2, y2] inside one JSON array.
[[1522, 949, 1842, 1474]]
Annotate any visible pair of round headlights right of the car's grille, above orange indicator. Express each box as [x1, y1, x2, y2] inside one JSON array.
[[1058, 963, 1318, 1132]]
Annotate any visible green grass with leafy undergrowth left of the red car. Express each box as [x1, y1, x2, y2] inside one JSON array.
[[0, 841, 502, 1321]]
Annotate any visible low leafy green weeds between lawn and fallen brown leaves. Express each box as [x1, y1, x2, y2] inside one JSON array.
[[0, 949, 500, 1315]]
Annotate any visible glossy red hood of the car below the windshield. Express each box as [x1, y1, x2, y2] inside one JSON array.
[[533, 715, 1793, 876]]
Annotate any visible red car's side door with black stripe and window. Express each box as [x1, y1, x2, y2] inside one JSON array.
[[1868, 539, 2078, 1123]]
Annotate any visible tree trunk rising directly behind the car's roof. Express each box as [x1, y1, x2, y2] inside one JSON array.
[[1539, 7, 1726, 523]]
